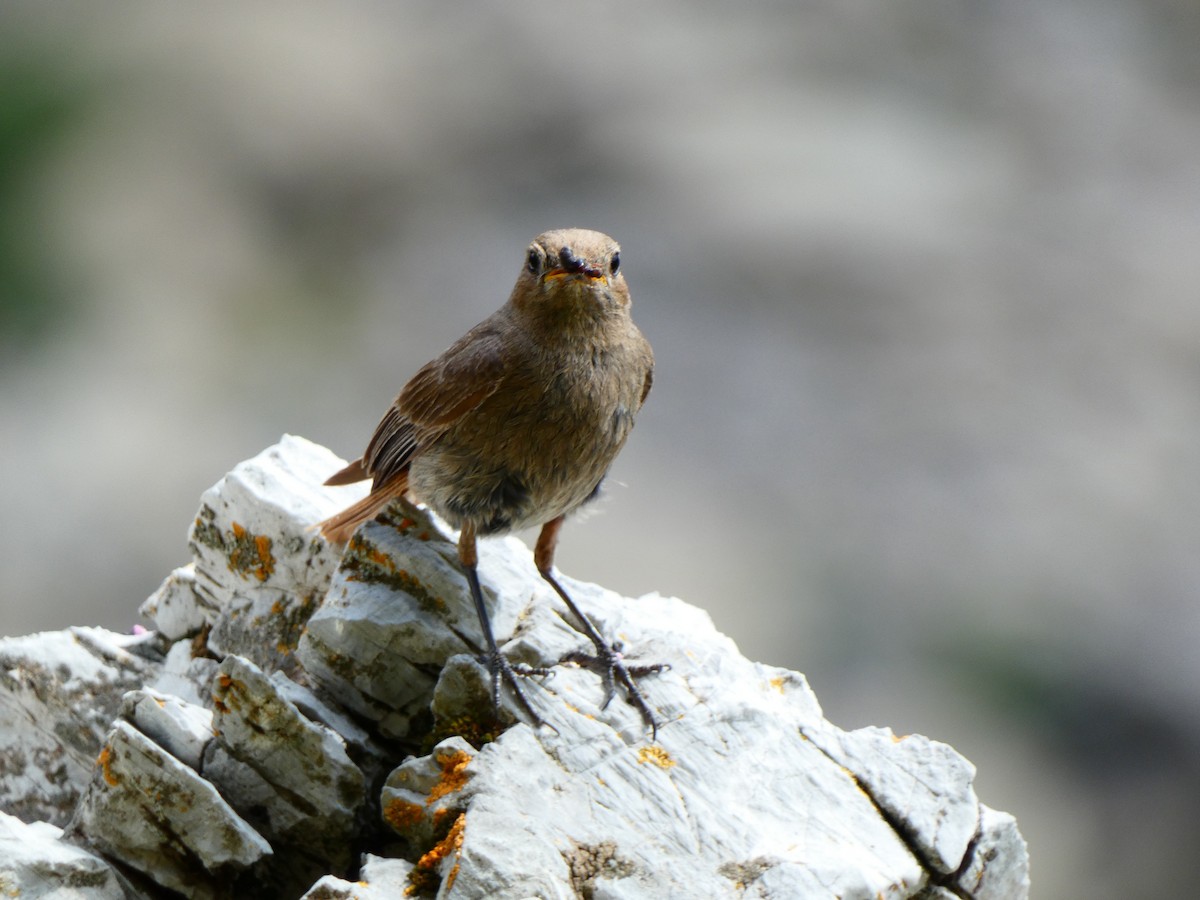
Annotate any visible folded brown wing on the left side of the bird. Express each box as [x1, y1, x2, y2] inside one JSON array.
[[362, 322, 504, 486]]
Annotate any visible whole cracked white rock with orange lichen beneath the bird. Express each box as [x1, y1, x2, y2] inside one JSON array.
[[0, 437, 1028, 900]]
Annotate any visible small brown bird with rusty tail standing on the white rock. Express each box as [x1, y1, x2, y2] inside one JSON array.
[[320, 228, 665, 731]]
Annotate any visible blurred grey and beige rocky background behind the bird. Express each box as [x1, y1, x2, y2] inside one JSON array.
[[0, 0, 1200, 900]]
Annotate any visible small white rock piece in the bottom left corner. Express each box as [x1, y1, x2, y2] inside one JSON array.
[[0, 812, 126, 900]]
